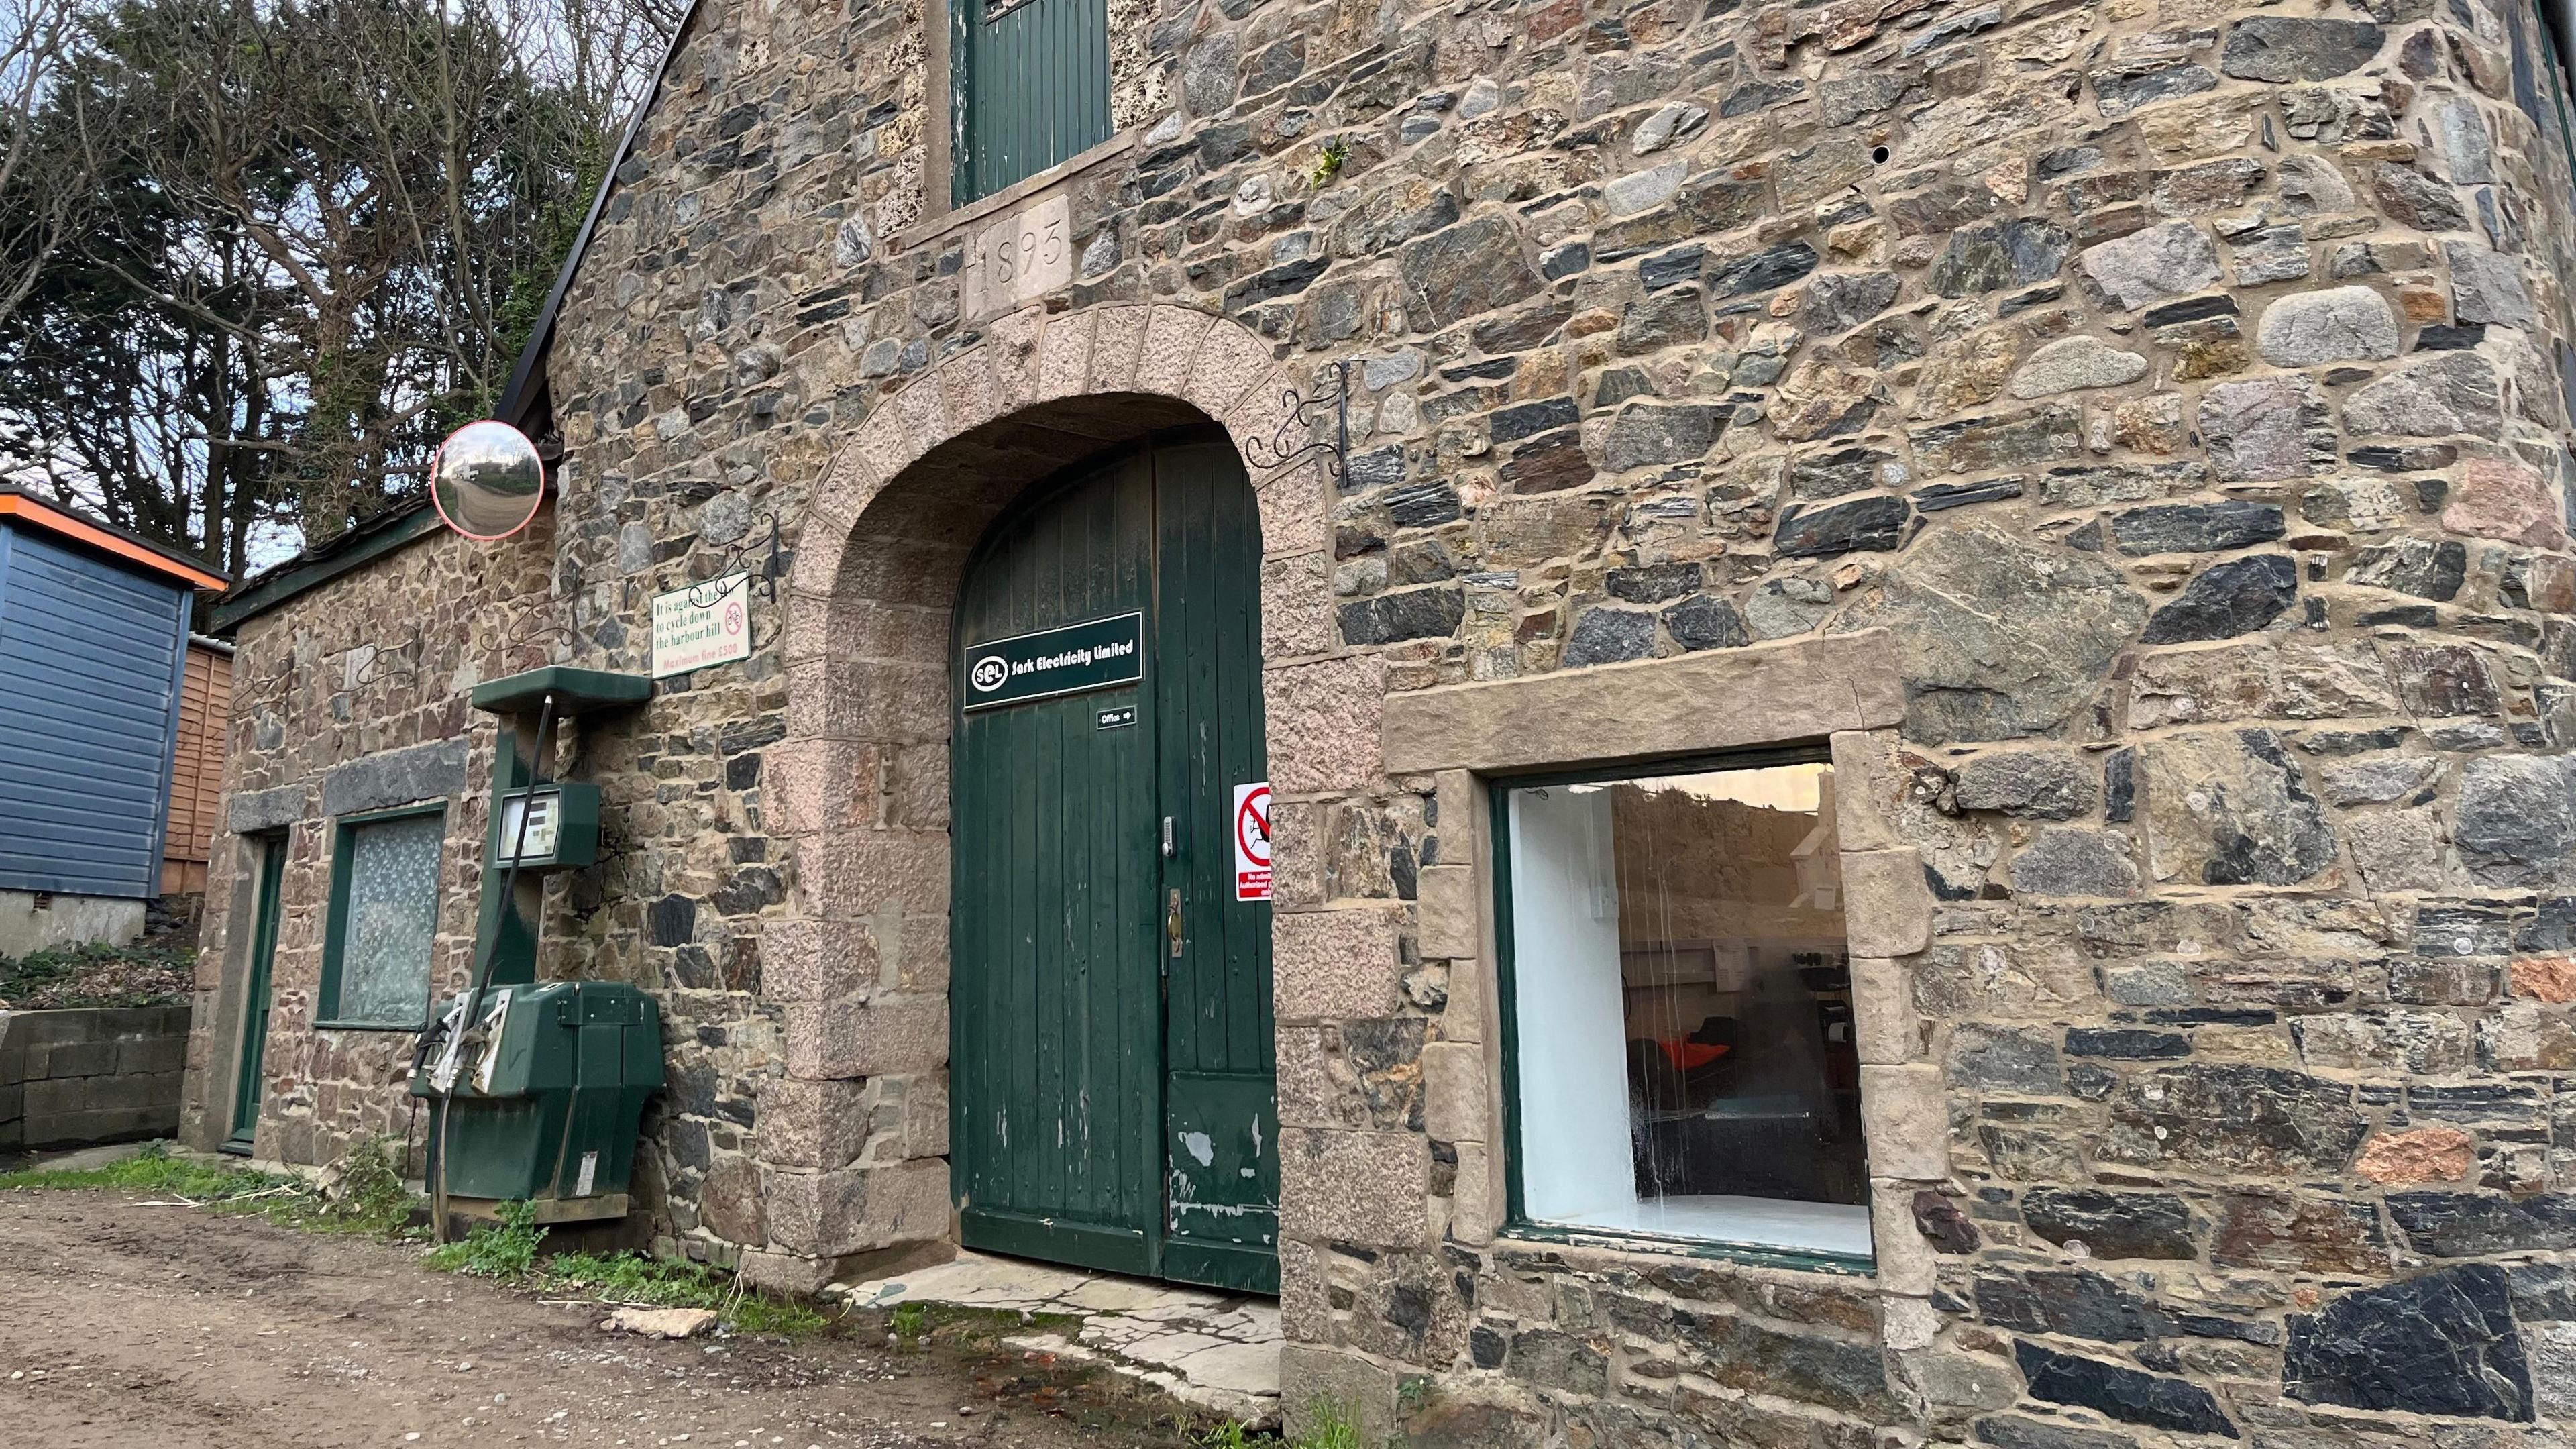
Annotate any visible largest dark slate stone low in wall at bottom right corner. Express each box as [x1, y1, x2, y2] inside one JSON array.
[[2279, 1263, 2532, 1421]]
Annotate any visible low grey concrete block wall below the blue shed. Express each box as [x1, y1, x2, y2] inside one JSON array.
[[0, 1006, 188, 1152]]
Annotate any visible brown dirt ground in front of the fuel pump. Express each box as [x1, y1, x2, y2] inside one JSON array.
[[0, 1191, 1226, 1449]]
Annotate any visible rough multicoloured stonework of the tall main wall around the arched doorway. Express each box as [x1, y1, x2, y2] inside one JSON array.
[[282, 0, 2576, 1423]]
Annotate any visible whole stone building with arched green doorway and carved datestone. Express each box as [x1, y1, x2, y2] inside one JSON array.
[[188, 0, 2576, 1449]]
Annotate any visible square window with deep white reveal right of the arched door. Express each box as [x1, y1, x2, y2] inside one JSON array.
[[1499, 755, 1870, 1258]]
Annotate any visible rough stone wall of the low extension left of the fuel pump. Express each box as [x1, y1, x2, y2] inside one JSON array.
[[180, 513, 554, 1171]]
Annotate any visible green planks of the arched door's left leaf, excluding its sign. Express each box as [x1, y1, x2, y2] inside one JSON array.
[[951, 445, 1162, 1274]]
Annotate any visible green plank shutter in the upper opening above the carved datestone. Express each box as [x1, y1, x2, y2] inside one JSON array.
[[948, 0, 1110, 206]]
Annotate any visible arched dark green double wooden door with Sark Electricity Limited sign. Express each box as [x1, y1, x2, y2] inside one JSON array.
[[951, 433, 1278, 1292]]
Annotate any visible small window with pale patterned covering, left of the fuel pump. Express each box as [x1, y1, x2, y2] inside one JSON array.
[[322, 807, 448, 1031]]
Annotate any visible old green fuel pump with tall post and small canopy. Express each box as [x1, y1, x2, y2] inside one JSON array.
[[412, 665, 662, 1238]]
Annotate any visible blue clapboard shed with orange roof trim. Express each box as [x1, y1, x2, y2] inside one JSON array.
[[0, 485, 227, 954]]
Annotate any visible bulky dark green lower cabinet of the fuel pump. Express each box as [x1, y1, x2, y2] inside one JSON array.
[[412, 982, 662, 1206]]
